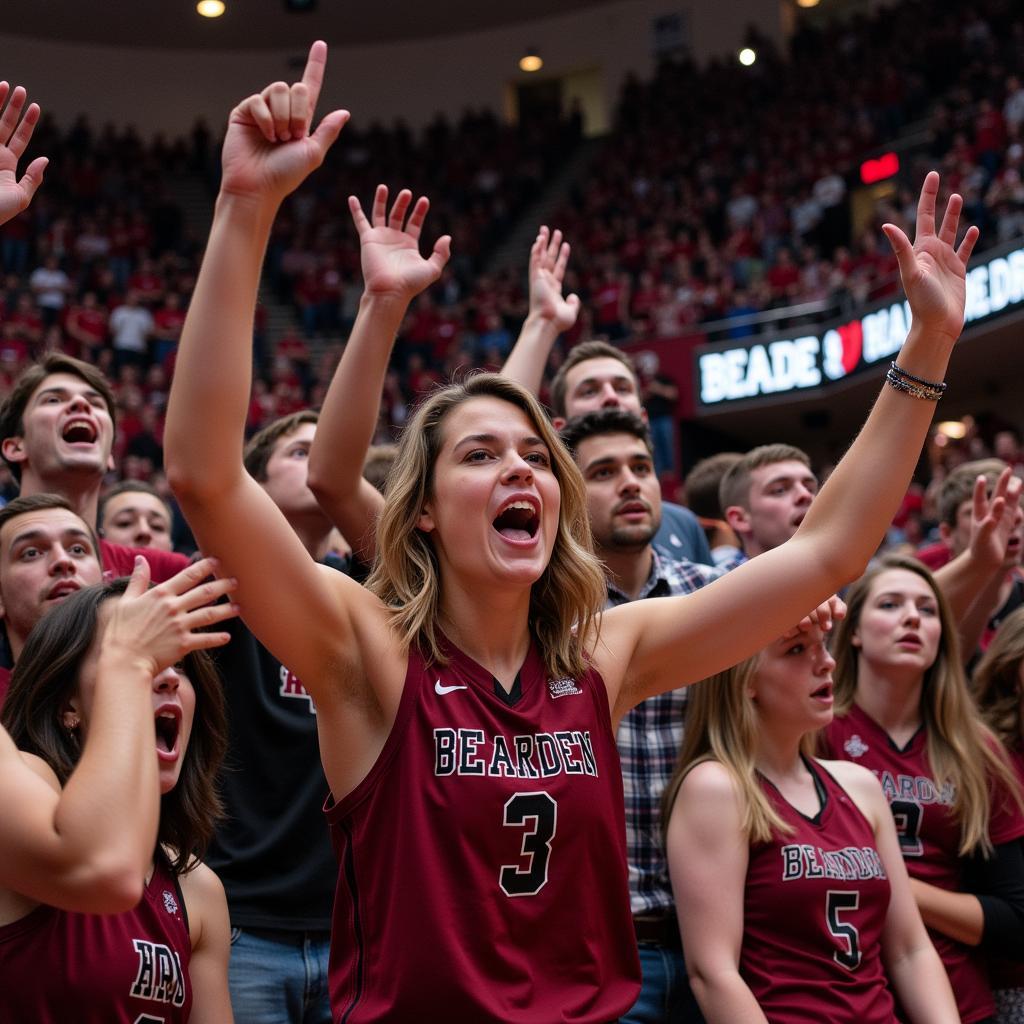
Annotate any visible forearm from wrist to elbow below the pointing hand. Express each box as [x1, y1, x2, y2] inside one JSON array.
[[165, 193, 275, 492]]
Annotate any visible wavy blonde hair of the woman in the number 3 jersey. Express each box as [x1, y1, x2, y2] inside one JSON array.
[[367, 373, 607, 679]]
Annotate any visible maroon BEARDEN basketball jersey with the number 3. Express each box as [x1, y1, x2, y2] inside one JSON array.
[[328, 645, 639, 1024]]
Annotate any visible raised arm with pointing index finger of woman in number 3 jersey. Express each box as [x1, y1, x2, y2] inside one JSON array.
[[165, 42, 368, 706]]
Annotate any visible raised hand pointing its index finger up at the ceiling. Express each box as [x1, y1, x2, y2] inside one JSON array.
[[220, 41, 348, 203]]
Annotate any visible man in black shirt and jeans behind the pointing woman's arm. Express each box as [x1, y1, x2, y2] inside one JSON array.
[[206, 410, 349, 1024]]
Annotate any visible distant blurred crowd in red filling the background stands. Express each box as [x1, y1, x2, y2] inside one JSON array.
[[0, 0, 1024, 495]]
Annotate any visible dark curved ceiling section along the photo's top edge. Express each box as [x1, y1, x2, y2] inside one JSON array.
[[0, 0, 607, 50]]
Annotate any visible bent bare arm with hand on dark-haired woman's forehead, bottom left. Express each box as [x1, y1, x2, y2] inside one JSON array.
[[0, 557, 236, 912]]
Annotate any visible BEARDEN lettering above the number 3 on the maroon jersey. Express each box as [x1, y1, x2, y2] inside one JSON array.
[[434, 728, 598, 778]]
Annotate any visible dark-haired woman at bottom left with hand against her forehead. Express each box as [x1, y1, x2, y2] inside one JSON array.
[[0, 559, 237, 1024]]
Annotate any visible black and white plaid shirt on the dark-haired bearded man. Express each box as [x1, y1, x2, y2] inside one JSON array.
[[606, 550, 725, 913]]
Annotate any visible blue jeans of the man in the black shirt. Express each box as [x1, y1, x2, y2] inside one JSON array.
[[227, 928, 331, 1024]]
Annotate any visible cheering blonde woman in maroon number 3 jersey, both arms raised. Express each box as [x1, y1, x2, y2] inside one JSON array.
[[165, 43, 977, 1024]]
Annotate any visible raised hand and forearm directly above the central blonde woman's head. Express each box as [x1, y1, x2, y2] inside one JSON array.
[[502, 226, 580, 395]]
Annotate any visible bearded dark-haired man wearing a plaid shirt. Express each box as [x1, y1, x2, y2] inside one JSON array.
[[561, 407, 722, 1024]]
